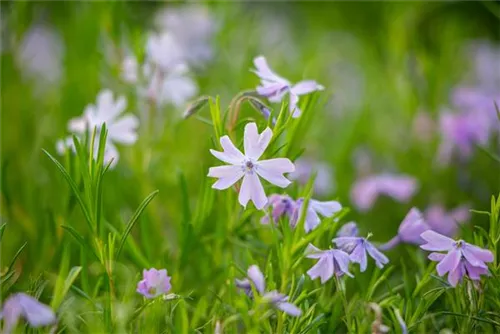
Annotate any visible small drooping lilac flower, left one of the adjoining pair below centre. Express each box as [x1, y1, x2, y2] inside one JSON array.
[[306, 244, 353, 284]]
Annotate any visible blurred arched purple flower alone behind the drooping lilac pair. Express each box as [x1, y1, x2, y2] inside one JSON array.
[[351, 174, 418, 211]]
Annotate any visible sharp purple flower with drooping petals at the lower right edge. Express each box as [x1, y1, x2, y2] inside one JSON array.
[[420, 230, 493, 286]]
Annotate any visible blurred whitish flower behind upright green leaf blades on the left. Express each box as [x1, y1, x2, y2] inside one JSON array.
[[56, 89, 139, 166]]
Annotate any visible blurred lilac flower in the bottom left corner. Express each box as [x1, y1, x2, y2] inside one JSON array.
[[0, 293, 56, 334]]
